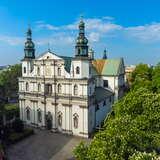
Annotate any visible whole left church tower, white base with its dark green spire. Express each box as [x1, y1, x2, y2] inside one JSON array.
[[22, 28, 35, 77]]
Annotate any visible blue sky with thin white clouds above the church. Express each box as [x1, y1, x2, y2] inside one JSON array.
[[0, 0, 160, 65]]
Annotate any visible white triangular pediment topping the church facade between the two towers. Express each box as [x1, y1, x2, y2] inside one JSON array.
[[37, 51, 62, 60]]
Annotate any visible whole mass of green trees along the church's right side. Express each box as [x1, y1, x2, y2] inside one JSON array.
[[74, 64, 160, 160]]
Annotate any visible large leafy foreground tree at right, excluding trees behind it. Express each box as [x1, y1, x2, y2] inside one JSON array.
[[75, 88, 160, 160]]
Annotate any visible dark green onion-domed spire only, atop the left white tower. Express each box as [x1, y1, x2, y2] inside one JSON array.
[[24, 28, 35, 59]]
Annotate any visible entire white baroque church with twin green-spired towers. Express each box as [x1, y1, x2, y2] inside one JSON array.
[[19, 20, 125, 138]]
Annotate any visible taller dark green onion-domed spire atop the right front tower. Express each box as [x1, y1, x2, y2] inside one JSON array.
[[75, 19, 88, 57]]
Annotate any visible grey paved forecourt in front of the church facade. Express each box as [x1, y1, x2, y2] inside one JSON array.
[[7, 130, 88, 160]]
